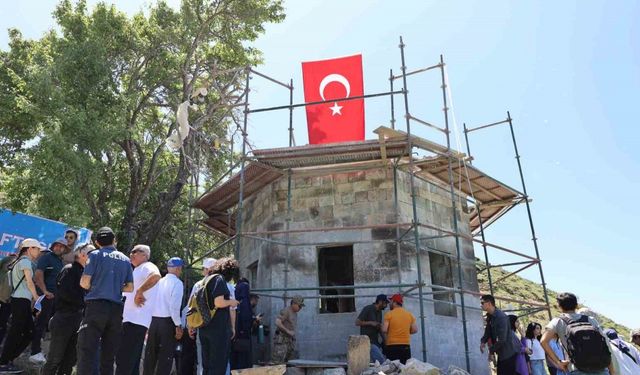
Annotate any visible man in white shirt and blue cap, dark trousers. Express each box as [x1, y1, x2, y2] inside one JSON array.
[[144, 257, 184, 375]]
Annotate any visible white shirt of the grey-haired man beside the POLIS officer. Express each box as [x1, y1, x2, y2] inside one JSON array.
[[122, 262, 160, 328]]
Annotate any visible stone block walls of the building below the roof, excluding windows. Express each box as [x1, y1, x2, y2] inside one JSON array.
[[239, 168, 488, 374]]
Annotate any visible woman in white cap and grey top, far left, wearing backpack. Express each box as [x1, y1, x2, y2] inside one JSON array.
[[0, 238, 45, 374]]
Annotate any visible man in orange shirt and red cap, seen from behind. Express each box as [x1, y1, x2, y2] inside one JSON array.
[[382, 294, 418, 364]]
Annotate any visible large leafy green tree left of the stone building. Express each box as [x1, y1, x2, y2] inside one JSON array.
[[0, 0, 284, 262]]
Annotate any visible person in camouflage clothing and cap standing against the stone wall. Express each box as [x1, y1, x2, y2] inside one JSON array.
[[271, 296, 304, 363]]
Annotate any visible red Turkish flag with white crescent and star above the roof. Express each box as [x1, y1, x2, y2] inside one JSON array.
[[302, 55, 364, 145]]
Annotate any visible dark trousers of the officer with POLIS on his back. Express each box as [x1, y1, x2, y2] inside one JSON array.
[[76, 299, 122, 375]]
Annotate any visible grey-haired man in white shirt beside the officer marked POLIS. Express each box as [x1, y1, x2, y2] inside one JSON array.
[[116, 245, 161, 375]]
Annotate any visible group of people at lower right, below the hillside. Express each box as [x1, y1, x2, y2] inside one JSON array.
[[480, 293, 640, 375]]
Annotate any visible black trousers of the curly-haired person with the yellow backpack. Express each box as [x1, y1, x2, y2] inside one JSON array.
[[198, 323, 231, 375]]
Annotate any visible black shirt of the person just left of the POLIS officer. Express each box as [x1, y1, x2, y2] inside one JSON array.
[[55, 262, 85, 312]]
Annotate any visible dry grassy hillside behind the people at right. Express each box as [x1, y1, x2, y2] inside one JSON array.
[[476, 262, 630, 341]]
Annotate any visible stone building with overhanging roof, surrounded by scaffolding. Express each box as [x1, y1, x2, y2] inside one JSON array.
[[196, 128, 518, 374]]
